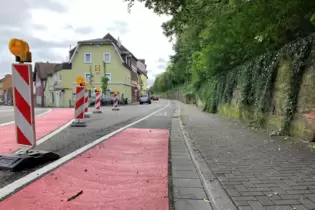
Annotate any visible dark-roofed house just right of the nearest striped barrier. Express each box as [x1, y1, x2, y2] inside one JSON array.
[[33, 62, 57, 107]]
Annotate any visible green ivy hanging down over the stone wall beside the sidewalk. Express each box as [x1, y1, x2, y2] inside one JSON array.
[[179, 34, 315, 138]]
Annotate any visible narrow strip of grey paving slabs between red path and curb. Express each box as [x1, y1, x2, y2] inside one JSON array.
[[171, 119, 212, 210]]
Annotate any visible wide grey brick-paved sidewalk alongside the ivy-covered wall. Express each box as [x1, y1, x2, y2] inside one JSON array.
[[176, 102, 315, 210]]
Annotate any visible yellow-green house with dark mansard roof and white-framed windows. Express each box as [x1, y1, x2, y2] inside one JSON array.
[[45, 34, 149, 107]]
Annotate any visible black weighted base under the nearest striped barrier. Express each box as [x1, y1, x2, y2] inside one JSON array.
[[0, 150, 60, 172]]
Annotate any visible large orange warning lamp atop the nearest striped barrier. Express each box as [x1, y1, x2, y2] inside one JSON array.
[[9, 38, 32, 63]]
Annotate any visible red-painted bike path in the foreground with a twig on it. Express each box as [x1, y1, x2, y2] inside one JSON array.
[[0, 128, 169, 210]]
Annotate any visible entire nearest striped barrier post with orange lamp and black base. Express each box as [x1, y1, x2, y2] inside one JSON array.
[[0, 39, 60, 171]]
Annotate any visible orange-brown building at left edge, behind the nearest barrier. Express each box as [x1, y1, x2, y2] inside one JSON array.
[[0, 74, 13, 105]]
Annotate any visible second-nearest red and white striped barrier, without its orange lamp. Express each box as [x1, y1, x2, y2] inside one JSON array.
[[71, 86, 86, 127]]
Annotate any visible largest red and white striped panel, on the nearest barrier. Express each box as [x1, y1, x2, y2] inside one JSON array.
[[12, 64, 36, 148]]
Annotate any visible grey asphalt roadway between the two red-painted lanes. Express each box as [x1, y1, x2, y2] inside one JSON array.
[[0, 100, 175, 188]]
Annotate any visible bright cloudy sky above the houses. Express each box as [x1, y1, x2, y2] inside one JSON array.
[[0, 0, 174, 86]]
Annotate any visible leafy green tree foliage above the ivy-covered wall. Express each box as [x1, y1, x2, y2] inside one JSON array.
[[124, 0, 315, 91]]
